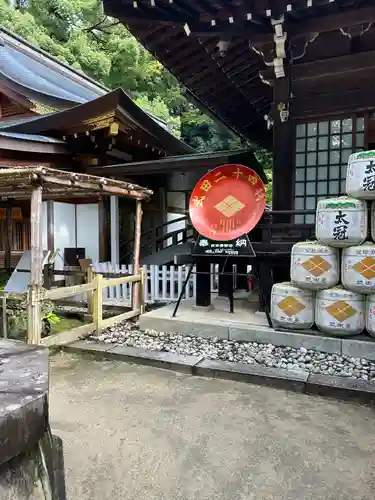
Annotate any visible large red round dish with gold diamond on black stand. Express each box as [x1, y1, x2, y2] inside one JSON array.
[[189, 165, 266, 241]]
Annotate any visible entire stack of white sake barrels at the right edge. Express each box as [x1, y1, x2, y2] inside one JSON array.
[[271, 151, 375, 336]]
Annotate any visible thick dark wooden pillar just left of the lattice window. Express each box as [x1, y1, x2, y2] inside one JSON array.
[[272, 67, 295, 214]]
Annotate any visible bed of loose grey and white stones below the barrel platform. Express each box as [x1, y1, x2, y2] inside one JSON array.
[[88, 322, 375, 380]]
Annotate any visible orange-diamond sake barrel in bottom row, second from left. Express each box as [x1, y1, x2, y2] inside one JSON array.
[[315, 286, 365, 337]]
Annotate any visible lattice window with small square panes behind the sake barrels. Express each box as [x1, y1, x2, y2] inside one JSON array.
[[295, 118, 364, 223]]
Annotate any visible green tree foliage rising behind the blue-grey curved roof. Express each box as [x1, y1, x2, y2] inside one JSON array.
[[0, 0, 270, 187]]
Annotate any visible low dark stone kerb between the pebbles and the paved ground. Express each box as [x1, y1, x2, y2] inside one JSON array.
[[61, 340, 375, 403]]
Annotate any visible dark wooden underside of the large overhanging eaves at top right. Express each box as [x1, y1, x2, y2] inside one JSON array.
[[103, 0, 375, 145]]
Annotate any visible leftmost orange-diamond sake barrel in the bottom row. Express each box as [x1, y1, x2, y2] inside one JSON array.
[[271, 282, 314, 330]]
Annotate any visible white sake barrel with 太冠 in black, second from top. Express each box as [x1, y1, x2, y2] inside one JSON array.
[[315, 196, 367, 248]]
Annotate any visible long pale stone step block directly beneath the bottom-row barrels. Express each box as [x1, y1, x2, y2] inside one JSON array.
[[229, 325, 341, 354]]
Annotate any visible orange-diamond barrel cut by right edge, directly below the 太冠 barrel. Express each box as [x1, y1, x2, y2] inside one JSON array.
[[341, 241, 375, 294]]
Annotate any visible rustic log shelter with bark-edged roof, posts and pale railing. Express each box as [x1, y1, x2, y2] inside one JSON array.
[[0, 166, 152, 345]]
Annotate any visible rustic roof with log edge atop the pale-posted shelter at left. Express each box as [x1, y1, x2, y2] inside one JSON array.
[[0, 166, 153, 200]]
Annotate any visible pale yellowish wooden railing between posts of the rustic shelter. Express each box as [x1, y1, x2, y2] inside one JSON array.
[[28, 269, 145, 346]]
